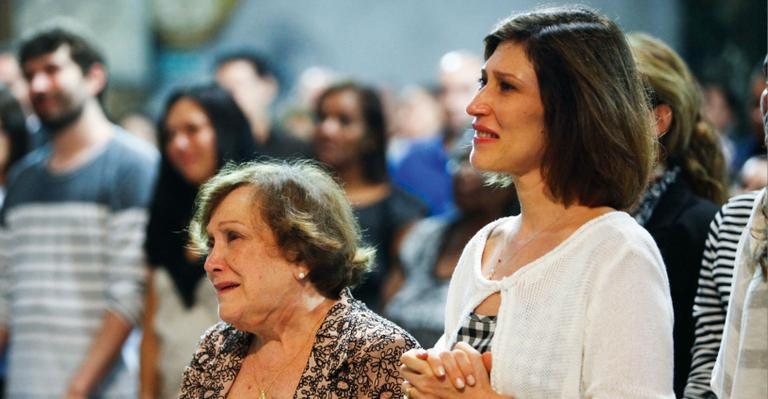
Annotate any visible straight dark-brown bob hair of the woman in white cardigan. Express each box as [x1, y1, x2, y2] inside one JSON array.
[[484, 6, 656, 209]]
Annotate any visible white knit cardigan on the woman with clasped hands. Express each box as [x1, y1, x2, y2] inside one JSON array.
[[436, 212, 674, 399]]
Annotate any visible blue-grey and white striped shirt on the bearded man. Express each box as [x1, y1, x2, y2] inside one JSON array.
[[0, 131, 157, 398]]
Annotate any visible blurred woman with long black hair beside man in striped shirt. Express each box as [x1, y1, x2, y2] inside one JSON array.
[[141, 85, 255, 398]]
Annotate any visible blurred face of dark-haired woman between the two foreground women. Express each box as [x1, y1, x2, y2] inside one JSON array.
[[314, 90, 367, 170]]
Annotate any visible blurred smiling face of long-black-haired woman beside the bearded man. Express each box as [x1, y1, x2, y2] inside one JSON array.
[[164, 97, 218, 185]]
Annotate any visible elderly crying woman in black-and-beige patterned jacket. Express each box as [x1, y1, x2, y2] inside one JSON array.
[[181, 163, 418, 398]]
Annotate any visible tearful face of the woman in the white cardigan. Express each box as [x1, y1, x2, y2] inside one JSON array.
[[467, 42, 546, 177]]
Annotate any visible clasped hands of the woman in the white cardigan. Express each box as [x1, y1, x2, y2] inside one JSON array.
[[400, 342, 502, 399]]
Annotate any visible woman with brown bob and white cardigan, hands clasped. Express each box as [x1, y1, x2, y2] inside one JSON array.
[[401, 6, 674, 398]]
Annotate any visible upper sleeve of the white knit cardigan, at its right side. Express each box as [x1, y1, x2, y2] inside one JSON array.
[[582, 243, 674, 398]]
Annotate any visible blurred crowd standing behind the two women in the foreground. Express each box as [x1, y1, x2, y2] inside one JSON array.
[[0, 11, 768, 398]]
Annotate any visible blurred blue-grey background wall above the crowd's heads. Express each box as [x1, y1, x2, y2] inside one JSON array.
[[0, 0, 767, 125]]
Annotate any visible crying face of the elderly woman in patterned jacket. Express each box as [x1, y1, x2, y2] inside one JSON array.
[[205, 186, 301, 329]]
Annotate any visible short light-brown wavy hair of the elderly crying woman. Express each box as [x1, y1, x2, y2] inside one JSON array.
[[189, 161, 374, 299]]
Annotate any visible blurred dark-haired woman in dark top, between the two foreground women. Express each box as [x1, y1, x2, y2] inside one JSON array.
[[313, 82, 426, 312]]
